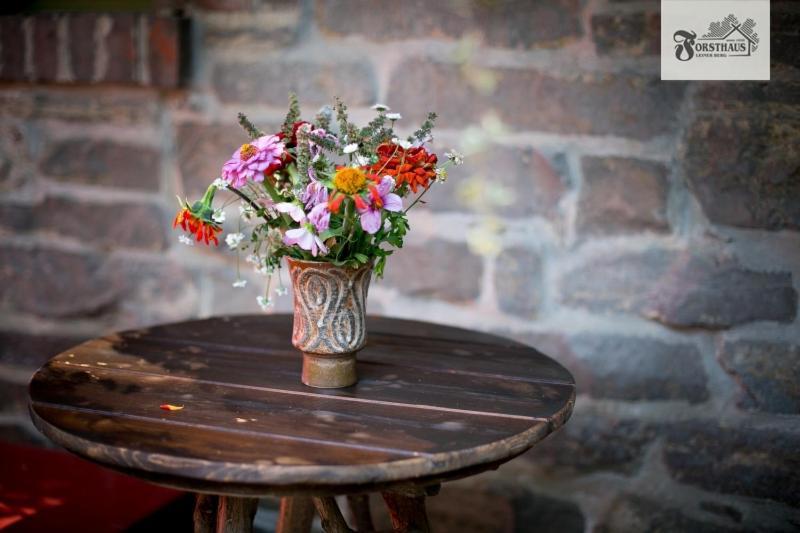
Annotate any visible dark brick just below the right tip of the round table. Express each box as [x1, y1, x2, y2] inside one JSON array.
[[523, 408, 656, 476]]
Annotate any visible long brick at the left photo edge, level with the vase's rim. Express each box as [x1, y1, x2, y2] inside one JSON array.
[[0, 246, 197, 327]]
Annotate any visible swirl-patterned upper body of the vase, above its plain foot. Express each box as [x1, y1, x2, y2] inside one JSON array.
[[289, 259, 372, 354]]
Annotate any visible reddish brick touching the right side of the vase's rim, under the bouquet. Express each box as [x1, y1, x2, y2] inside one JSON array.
[[376, 240, 483, 302]]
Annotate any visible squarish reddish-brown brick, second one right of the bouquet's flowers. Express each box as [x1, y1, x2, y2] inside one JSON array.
[[576, 157, 669, 235]]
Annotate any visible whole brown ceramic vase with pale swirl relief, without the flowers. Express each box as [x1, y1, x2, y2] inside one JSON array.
[[288, 258, 372, 389]]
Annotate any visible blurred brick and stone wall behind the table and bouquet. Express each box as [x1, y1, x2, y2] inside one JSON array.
[[0, 0, 800, 532]]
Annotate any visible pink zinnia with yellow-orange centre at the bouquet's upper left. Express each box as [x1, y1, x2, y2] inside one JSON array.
[[222, 135, 284, 189]]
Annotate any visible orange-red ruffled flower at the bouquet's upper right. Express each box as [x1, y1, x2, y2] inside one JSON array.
[[370, 143, 438, 194]]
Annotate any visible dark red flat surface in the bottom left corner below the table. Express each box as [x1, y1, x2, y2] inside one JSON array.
[[0, 442, 183, 533]]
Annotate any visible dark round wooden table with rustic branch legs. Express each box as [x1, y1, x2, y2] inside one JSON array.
[[30, 315, 575, 532]]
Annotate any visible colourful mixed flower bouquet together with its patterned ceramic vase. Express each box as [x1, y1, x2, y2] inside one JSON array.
[[174, 95, 462, 387]]
